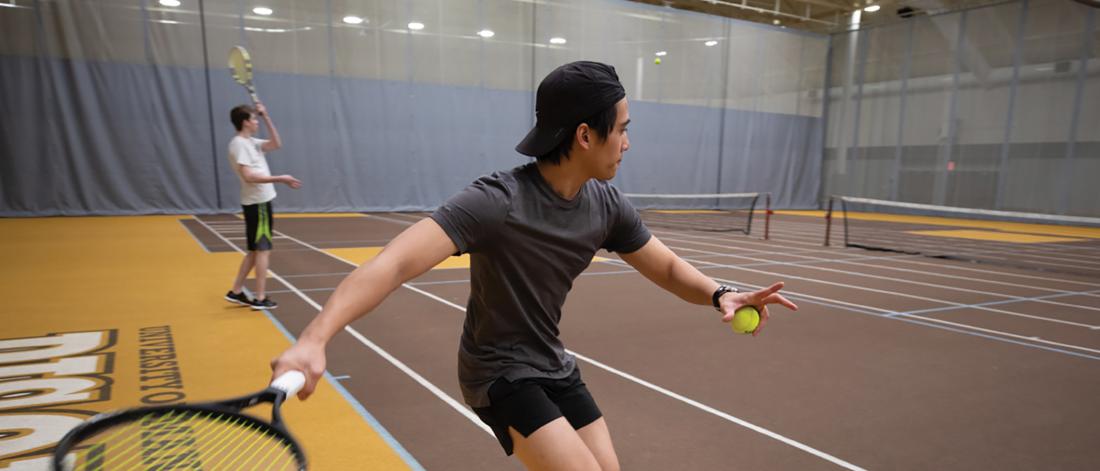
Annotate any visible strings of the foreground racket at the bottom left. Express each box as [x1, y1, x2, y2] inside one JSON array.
[[63, 410, 300, 470]]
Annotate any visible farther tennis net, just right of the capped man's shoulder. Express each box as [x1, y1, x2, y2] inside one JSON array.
[[626, 193, 771, 239]]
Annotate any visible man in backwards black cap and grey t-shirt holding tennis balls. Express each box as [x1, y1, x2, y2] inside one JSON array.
[[272, 62, 796, 471]]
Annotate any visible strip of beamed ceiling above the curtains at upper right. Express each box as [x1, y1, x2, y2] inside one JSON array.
[[633, 0, 1005, 33]]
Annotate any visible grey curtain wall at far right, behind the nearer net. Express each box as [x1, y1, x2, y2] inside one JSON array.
[[823, 0, 1100, 217]]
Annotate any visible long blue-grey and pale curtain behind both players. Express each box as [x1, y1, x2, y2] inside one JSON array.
[[0, 0, 829, 216]]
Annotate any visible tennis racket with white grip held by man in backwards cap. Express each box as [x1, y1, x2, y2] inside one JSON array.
[[52, 371, 306, 471]]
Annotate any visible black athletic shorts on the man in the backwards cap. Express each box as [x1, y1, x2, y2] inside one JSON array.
[[474, 368, 603, 456]]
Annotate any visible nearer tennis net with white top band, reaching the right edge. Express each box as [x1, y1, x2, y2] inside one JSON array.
[[825, 196, 1100, 276]]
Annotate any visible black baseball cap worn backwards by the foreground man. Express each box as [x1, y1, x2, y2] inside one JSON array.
[[516, 61, 626, 157]]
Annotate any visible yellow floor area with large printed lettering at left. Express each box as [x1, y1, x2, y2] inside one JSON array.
[[0, 216, 409, 470]]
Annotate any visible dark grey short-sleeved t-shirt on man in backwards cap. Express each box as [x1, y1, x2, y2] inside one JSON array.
[[431, 163, 650, 407]]
